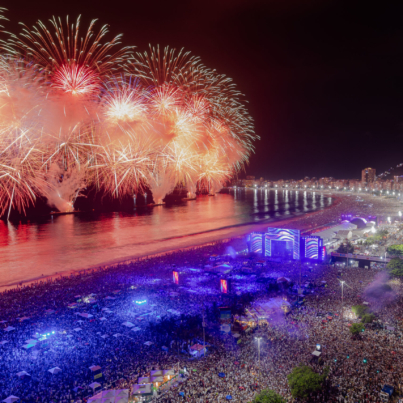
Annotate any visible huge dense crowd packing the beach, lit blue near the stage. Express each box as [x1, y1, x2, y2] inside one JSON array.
[[0, 191, 403, 403]]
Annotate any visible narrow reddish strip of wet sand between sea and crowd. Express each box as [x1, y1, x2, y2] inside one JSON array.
[[0, 195, 343, 294]]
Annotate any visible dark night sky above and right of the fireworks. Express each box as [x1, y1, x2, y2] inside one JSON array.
[[2, 0, 403, 179]]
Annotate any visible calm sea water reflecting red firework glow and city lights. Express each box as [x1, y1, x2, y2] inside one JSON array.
[[0, 189, 332, 287]]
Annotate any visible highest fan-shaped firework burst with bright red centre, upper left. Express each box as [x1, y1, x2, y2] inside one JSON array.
[[8, 17, 131, 95]]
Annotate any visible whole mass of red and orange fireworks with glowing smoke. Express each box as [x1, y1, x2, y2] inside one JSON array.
[[0, 10, 258, 215]]
